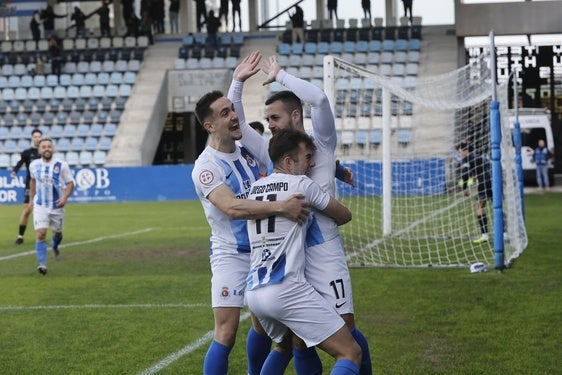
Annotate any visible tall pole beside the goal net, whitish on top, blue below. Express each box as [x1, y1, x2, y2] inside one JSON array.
[[490, 31, 505, 270]]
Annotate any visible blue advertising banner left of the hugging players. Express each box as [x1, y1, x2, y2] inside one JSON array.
[[0, 165, 198, 204]]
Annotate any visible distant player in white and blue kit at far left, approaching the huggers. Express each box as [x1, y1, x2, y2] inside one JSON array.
[[29, 138, 74, 275]]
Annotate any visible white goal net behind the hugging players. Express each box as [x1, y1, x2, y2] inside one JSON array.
[[324, 54, 527, 267]]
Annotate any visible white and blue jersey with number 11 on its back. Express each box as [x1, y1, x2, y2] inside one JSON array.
[[247, 173, 330, 290]]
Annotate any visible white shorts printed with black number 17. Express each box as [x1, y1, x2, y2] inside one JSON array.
[[304, 236, 354, 315]]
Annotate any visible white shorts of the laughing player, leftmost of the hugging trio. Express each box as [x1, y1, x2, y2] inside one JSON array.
[[210, 253, 250, 308]]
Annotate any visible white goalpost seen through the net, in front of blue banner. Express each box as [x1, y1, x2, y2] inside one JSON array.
[[382, 87, 392, 237]]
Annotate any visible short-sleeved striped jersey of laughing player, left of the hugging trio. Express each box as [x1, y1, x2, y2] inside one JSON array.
[[191, 146, 259, 254]]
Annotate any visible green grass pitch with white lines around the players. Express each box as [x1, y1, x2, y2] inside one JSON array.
[[0, 193, 562, 375]]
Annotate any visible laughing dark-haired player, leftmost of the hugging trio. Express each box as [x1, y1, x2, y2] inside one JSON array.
[[191, 91, 310, 375]]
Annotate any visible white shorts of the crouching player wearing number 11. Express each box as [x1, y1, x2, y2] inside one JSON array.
[[246, 280, 345, 347]]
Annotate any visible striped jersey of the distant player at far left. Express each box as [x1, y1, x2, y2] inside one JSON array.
[[29, 159, 74, 208]]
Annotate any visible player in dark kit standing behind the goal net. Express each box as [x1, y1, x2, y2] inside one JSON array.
[[457, 141, 492, 244]]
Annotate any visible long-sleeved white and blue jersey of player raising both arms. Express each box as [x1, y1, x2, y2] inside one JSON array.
[[228, 70, 339, 244]]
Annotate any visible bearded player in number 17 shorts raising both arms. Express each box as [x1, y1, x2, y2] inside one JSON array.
[[228, 51, 372, 374]]
